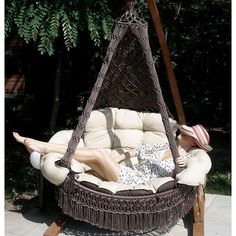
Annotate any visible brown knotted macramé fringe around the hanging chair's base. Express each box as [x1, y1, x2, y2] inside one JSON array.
[[57, 176, 196, 232]]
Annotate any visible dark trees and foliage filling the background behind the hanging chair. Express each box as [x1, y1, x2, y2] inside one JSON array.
[[5, 0, 231, 195]]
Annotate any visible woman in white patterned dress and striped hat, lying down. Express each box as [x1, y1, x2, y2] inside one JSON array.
[[13, 125, 212, 185]]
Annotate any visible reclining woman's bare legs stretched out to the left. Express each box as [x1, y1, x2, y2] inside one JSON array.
[[13, 133, 119, 181]]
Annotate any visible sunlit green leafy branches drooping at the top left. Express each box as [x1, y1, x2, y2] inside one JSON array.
[[5, 0, 112, 55]]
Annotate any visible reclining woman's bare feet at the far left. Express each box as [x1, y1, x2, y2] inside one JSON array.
[[12, 132, 46, 155]]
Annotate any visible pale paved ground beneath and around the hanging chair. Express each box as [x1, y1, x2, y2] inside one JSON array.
[[5, 194, 231, 236]]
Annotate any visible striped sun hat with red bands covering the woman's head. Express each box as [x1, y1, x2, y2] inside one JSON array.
[[179, 125, 212, 152]]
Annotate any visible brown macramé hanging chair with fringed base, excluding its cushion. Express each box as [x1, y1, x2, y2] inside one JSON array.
[[37, 1, 210, 232]]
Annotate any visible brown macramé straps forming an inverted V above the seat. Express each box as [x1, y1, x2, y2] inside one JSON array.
[[57, 6, 182, 174]]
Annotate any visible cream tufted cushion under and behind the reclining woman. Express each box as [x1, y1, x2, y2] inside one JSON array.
[[41, 108, 211, 193]]
